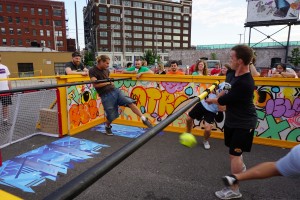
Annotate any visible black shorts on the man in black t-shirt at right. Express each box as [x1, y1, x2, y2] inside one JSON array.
[[224, 126, 254, 156]]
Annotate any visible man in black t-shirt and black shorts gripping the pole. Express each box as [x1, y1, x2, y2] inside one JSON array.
[[206, 45, 257, 199]]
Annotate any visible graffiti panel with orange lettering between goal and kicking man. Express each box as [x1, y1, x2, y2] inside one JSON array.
[[67, 84, 103, 129]]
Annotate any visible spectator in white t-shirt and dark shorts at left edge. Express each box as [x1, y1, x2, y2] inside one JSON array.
[[0, 54, 12, 125]]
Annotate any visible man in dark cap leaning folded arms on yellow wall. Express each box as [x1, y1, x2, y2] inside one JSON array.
[[65, 52, 89, 76]]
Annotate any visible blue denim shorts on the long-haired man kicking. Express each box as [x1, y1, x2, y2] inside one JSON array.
[[100, 88, 135, 122]]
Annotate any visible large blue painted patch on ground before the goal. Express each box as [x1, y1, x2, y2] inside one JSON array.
[[0, 137, 109, 193]]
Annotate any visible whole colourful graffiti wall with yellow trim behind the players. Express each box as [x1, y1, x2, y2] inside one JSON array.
[[68, 77, 300, 142]]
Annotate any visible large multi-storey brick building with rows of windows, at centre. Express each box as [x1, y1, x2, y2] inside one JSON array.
[[84, 0, 192, 66]]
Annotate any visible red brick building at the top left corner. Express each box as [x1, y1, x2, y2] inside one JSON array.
[[0, 0, 67, 51]]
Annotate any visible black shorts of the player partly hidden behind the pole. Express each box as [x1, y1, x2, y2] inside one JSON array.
[[189, 102, 216, 124]]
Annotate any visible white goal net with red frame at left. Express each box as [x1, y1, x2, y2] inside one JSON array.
[[0, 89, 58, 148]]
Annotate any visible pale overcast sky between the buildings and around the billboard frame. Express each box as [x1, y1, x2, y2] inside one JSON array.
[[63, 0, 300, 48]]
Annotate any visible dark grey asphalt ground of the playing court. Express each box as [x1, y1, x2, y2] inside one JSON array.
[[0, 130, 300, 200]]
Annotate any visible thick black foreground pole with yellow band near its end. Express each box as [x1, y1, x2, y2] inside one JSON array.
[[44, 81, 219, 200]]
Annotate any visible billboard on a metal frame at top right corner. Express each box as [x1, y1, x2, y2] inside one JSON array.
[[247, 0, 300, 22]]
